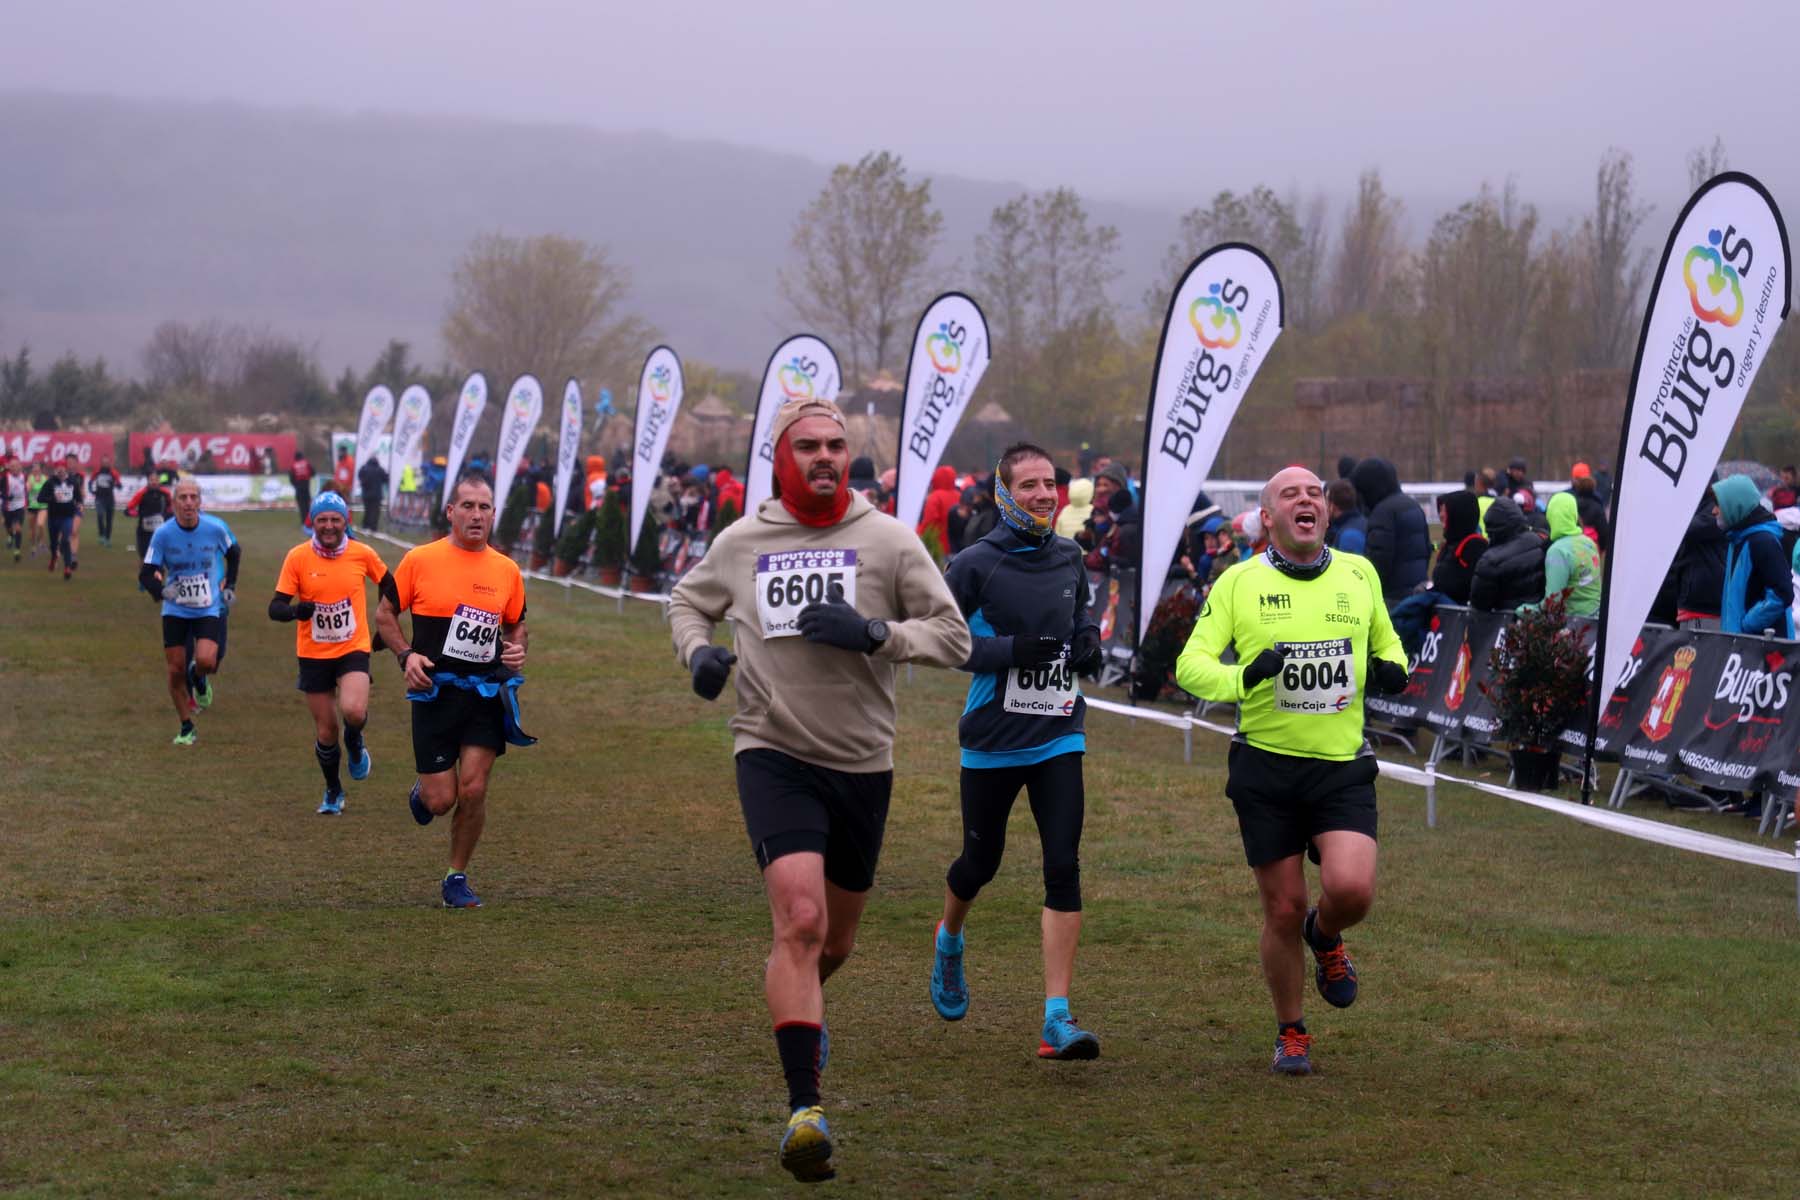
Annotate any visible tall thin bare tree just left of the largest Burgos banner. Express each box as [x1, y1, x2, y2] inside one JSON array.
[[1575, 149, 1651, 367]]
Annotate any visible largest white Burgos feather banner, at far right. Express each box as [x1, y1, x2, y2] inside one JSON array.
[[1588, 171, 1791, 755]]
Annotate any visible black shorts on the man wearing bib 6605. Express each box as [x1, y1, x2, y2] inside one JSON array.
[[738, 748, 895, 892]]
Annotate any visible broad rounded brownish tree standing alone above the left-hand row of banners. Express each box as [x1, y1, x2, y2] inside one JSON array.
[[443, 234, 653, 399]]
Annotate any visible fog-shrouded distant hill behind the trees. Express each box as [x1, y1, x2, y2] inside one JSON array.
[[0, 92, 1173, 387]]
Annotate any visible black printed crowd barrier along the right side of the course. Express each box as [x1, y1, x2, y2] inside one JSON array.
[[1364, 604, 1800, 790]]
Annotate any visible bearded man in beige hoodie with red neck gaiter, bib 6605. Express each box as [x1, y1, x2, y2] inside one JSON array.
[[670, 399, 970, 1180]]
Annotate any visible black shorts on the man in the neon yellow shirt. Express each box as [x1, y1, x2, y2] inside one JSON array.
[[1226, 741, 1375, 867]]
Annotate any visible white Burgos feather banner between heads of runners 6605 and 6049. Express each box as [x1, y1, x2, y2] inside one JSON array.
[[895, 291, 990, 528]]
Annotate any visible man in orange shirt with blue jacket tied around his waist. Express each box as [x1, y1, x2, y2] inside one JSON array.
[[374, 471, 533, 909]]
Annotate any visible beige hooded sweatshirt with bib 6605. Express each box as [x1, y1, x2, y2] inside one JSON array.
[[670, 493, 970, 774]]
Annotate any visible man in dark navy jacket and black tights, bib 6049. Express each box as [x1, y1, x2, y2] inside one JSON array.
[[931, 443, 1100, 1058]]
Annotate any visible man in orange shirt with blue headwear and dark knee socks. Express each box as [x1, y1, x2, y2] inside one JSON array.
[[268, 491, 394, 817]]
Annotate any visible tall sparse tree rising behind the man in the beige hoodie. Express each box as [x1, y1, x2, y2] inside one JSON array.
[[781, 151, 943, 380]]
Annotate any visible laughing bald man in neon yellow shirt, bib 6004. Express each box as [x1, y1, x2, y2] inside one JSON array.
[[1175, 468, 1406, 1074]]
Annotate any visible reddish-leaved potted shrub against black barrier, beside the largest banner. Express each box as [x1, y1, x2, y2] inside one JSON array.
[[1481, 596, 1588, 792]]
